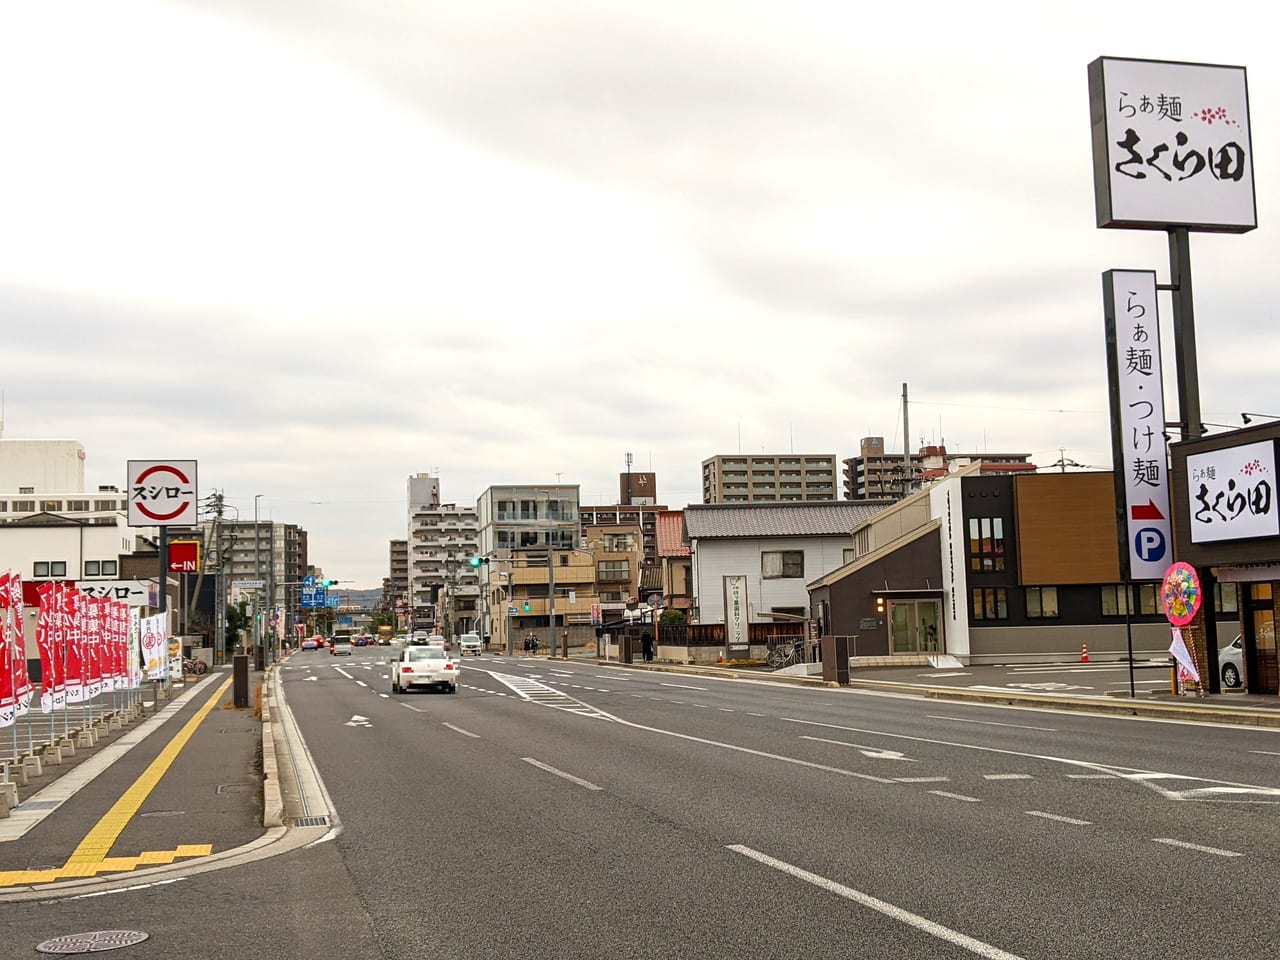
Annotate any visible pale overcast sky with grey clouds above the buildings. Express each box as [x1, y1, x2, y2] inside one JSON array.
[[0, 0, 1280, 586]]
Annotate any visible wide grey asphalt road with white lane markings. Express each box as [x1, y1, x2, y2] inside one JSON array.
[[5, 648, 1280, 959]]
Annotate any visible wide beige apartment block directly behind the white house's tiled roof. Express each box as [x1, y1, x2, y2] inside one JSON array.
[[703, 453, 837, 503]]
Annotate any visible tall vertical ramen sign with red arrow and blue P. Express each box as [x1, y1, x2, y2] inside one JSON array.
[[1102, 270, 1172, 581]]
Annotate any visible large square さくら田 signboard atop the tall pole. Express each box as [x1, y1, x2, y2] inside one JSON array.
[[1089, 56, 1258, 233]]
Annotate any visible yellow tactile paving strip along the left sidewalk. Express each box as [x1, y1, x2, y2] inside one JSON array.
[[0, 677, 232, 887]]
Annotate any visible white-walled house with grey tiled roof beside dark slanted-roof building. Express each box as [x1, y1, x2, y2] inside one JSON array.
[[685, 500, 888, 623]]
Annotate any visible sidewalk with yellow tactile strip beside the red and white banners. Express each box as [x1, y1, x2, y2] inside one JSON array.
[[0, 668, 262, 892]]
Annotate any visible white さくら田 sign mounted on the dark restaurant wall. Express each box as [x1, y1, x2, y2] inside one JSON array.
[[1187, 440, 1280, 543]]
